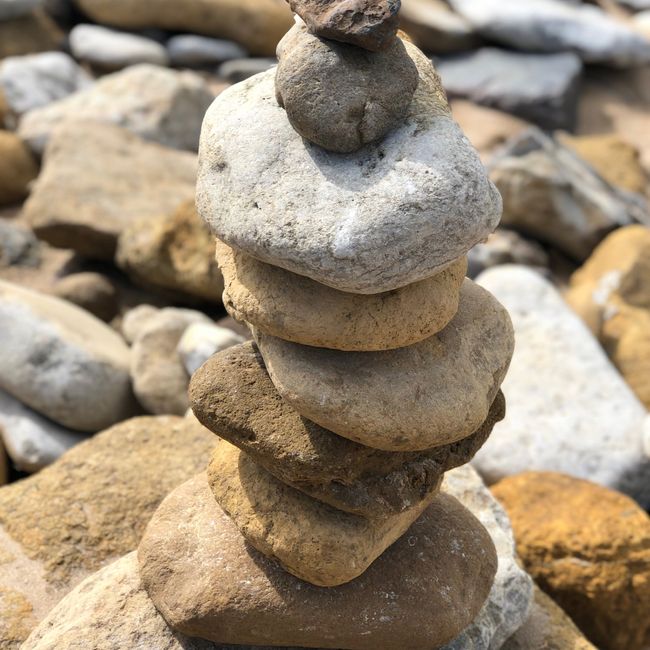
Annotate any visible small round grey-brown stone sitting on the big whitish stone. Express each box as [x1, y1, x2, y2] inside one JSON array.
[[275, 25, 419, 153]]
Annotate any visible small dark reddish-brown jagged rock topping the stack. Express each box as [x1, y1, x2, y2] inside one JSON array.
[[287, 0, 401, 52]]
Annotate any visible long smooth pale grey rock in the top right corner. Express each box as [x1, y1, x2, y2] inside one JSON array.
[[449, 0, 650, 67]]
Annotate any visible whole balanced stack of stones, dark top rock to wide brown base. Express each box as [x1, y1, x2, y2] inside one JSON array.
[[139, 0, 513, 650]]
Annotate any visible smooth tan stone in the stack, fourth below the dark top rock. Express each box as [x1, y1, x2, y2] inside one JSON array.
[[256, 280, 514, 451]]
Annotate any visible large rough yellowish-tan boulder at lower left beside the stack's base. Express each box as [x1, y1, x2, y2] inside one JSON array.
[[0, 417, 214, 650]]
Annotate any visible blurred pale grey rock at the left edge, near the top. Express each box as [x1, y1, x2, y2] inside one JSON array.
[[0, 52, 92, 126]]
